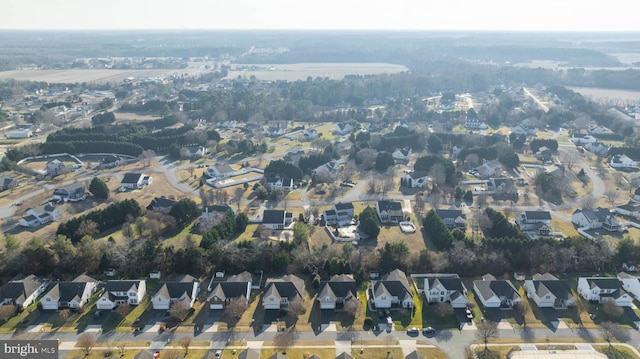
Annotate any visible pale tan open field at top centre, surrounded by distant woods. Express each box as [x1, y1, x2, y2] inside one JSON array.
[[225, 63, 408, 81]]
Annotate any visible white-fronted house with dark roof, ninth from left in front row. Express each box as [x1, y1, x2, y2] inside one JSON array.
[[423, 273, 468, 308]]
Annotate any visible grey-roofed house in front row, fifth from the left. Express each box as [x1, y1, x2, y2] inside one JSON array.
[[207, 272, 253, 310]]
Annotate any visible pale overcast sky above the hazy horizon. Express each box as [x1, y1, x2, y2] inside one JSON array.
[[0, 0, 640, 31]]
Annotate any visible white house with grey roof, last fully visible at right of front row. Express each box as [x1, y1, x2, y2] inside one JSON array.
[[578, 277, 633, 307]]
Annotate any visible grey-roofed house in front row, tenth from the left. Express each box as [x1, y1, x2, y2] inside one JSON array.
[[473, 274, 522, 308]]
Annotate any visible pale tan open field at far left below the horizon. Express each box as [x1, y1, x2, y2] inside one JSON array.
[[0, 68, 210, 83]]
